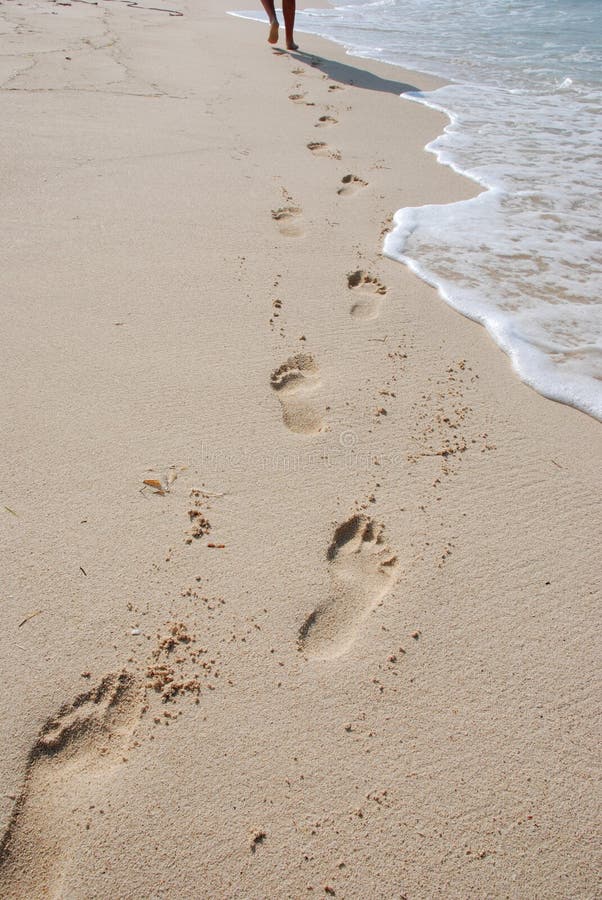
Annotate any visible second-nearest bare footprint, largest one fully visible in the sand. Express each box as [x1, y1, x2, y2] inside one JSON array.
[[299, 515, 398, 659]]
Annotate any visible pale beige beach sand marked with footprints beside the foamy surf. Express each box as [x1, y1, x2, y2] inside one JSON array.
[[0, 0, 602, 900]]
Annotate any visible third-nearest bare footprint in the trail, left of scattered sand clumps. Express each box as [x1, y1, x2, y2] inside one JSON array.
[[270, 353, 324, 434]]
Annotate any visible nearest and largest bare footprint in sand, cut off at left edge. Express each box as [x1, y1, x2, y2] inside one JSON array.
[[0, 672, 142, 900]]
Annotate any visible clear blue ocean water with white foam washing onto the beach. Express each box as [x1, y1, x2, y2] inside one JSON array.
[[231, 0, 602, 419]]
